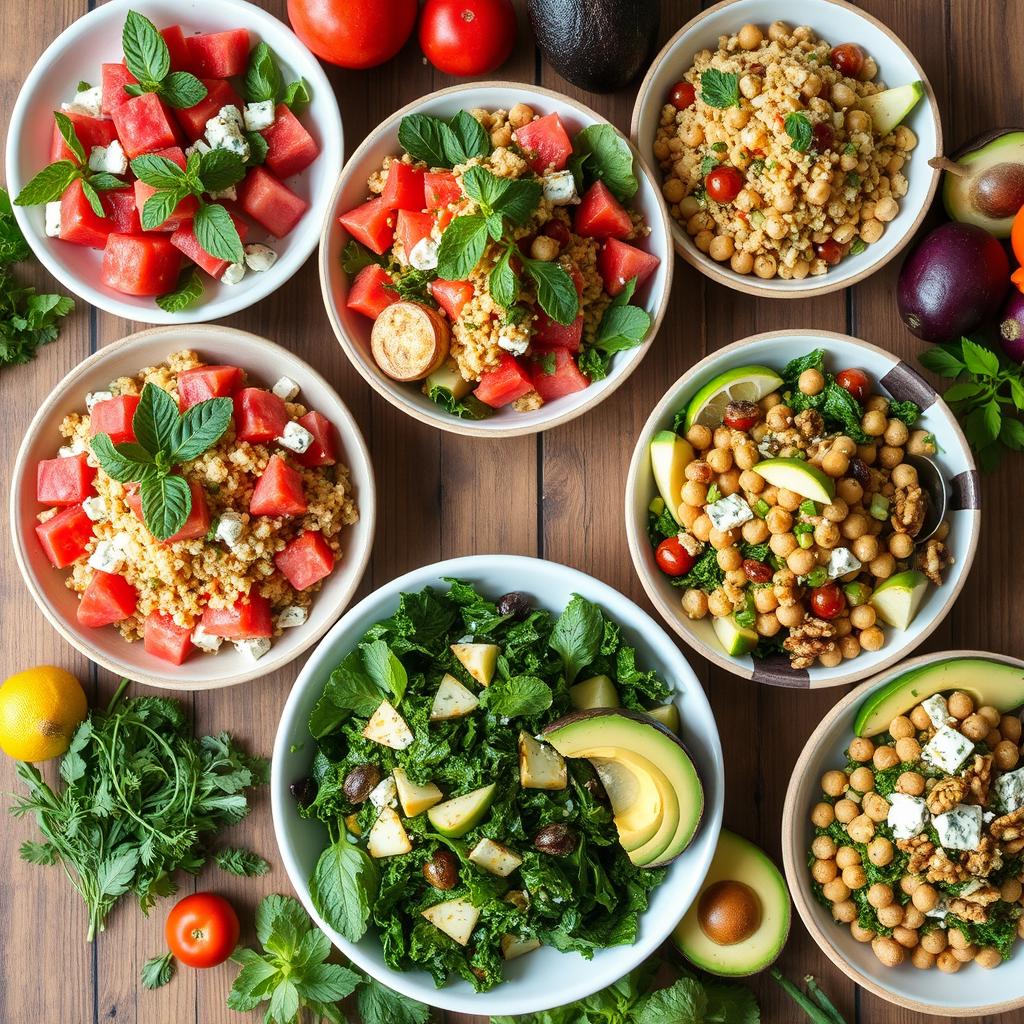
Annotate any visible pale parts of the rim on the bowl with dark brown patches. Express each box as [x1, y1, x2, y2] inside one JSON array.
[[625, 329, 981, 689]]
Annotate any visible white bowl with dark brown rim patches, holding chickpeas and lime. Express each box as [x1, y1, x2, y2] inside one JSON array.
[[626, 331, 981, 688]]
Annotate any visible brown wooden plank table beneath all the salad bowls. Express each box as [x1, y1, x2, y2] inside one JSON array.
[[0, 0, 1024, 1024]]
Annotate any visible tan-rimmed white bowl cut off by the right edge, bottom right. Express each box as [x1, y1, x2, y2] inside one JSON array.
[[782, 650, 1024, 1020]]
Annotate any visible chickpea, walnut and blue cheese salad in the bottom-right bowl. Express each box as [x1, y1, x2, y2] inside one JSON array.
[[808, 684, 1024, 974]]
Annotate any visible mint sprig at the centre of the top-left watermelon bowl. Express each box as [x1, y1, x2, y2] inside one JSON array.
[[131, 150, 246, 263]]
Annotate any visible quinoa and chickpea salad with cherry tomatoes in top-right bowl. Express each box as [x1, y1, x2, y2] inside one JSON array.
[[653, 22, 923, 281]]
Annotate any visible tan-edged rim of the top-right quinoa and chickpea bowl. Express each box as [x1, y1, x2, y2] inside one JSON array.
[[630, 0, 942, 299]]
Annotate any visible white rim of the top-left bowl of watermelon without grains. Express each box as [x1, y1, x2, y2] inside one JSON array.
[[5, 0, 345, 327]]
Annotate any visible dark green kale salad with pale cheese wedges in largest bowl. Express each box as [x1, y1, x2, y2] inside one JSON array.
[[293, 580, 670, 991]]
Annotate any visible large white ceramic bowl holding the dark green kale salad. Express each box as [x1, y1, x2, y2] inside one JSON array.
[[270, 555, 724, 1015]]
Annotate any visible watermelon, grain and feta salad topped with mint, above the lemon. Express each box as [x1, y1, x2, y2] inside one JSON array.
[[35, 350, 358, 665]]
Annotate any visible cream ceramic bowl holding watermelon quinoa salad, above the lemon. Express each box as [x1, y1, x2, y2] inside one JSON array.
[[8, 326, 376, 690]]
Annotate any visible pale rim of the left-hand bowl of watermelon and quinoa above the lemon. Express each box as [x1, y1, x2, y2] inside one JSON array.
[[7, 324, 377, 690]]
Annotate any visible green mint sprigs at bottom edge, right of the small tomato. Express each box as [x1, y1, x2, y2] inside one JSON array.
[[227, 895, 430, 1024]]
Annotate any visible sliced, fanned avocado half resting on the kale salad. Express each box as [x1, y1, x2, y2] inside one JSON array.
[[544, 708, 703, 867]]
